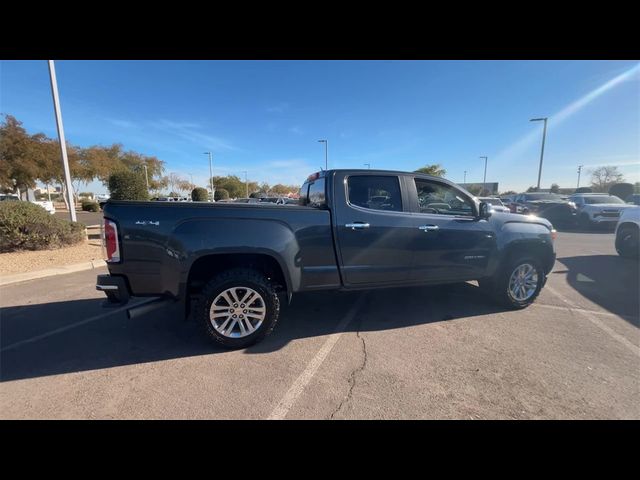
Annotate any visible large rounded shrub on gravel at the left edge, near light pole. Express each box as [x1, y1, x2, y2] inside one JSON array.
[[0, 202, 85, 252]]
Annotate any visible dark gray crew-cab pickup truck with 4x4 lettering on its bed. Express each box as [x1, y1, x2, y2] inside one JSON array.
[[96, 170, 555, 348]]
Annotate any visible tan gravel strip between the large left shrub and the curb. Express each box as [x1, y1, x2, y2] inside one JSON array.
[[0, 239, 102, 275]]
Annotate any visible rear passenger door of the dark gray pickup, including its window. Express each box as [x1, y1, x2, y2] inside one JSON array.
[[333, 171, 414, 286]]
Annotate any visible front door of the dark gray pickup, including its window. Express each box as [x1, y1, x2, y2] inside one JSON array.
[[407, 176, 497, 283]]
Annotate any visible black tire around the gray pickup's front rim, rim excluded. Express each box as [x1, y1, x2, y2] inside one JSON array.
[[478, 256, 546, 310]]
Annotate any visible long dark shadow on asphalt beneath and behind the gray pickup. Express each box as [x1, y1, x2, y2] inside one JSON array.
[[0, 283, 504, 382]]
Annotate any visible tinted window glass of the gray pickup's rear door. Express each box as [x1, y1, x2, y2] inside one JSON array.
[[347, 175, 402, 212]]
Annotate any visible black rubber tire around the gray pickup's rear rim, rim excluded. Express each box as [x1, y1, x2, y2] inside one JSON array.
[[194, 268, 280, 349]]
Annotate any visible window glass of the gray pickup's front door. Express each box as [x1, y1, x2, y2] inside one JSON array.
[[415, 178, 474, 217]]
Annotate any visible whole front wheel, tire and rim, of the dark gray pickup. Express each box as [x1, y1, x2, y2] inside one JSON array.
[[478, 256, 546, 309]]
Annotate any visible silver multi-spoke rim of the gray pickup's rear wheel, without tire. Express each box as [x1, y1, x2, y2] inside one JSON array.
[[209, 287, 267, 338]]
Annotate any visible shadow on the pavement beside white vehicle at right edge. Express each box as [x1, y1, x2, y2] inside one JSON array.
[[558, 255, 640, 327]]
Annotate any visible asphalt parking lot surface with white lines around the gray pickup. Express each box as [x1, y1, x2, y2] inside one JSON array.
[[0, 227, 640, 419]]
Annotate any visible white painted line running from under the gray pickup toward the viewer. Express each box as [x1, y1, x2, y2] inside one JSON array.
[[267, 294, 366, 420]]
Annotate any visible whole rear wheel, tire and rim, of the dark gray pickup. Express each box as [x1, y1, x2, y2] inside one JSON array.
[[195, 268, 280, 349]]
